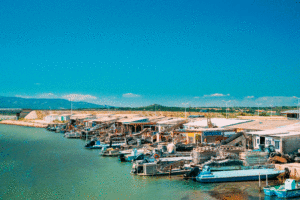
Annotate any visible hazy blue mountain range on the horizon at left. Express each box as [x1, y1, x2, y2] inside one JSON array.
[[0, 96, 107, 110]]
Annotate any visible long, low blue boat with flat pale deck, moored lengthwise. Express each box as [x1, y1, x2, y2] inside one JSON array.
[[196, 166, 285, 183]]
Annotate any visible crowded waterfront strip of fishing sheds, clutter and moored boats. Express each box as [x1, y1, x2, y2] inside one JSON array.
[[1, 109, 300, 192]]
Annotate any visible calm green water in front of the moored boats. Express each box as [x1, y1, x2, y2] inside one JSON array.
[[0, 125, 270, 200]]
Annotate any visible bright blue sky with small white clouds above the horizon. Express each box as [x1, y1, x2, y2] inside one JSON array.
[[0, 0, 300, 106]]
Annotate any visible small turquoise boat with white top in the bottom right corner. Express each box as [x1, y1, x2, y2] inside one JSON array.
[[264, 179, 300, 198]]
